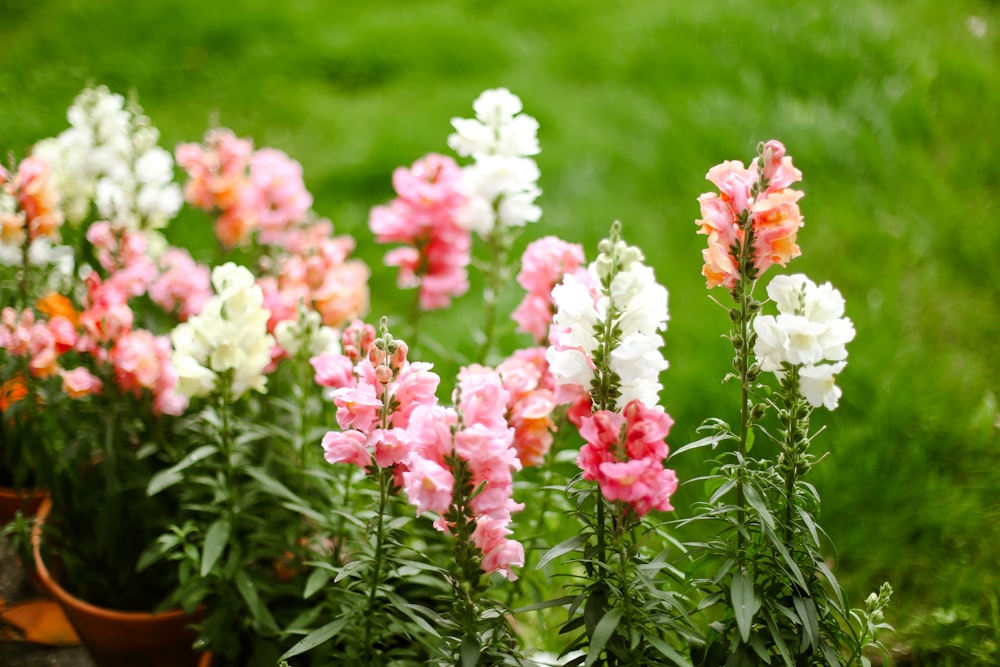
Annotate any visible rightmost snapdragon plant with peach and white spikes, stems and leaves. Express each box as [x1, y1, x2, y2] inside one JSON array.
[[681, 141, 888, 667]]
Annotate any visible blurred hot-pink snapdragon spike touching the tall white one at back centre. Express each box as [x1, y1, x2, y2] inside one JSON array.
[[368, 154, 472, 310]]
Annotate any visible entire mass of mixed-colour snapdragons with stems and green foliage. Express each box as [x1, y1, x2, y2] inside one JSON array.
[[0, 89, 891, 667]]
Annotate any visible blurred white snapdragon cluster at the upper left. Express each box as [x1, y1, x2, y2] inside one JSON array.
[[32, 86, 182, 229]]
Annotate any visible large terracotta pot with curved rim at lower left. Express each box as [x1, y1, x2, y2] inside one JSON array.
[[31, 499, 201, 667]]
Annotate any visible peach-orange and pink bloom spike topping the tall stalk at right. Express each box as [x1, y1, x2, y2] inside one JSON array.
[[697, 140, 802, 289]]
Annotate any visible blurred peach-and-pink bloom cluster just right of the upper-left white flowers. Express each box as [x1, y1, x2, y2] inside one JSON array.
[[176, 128, 313, 248]]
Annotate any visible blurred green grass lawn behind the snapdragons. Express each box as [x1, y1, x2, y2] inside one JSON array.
[[0, 0, 1000, 664]]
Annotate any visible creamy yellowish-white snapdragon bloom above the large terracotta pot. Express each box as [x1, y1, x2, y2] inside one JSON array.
[[170, 262, 274, 398]]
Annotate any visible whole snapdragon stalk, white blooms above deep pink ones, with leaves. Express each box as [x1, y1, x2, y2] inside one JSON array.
[[541, 222, 683, 665]]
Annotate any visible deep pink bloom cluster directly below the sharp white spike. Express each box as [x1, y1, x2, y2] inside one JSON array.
[[577, 400, 677, 517]]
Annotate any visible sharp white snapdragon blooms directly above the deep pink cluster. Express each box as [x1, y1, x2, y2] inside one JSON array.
[[545, 225, 669, 410]]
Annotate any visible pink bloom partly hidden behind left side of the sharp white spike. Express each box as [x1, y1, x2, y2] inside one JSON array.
[[511, 236, 586, 343]]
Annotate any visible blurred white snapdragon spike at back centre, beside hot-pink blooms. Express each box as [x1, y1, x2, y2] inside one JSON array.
[[448, 88, 542, 238]]
